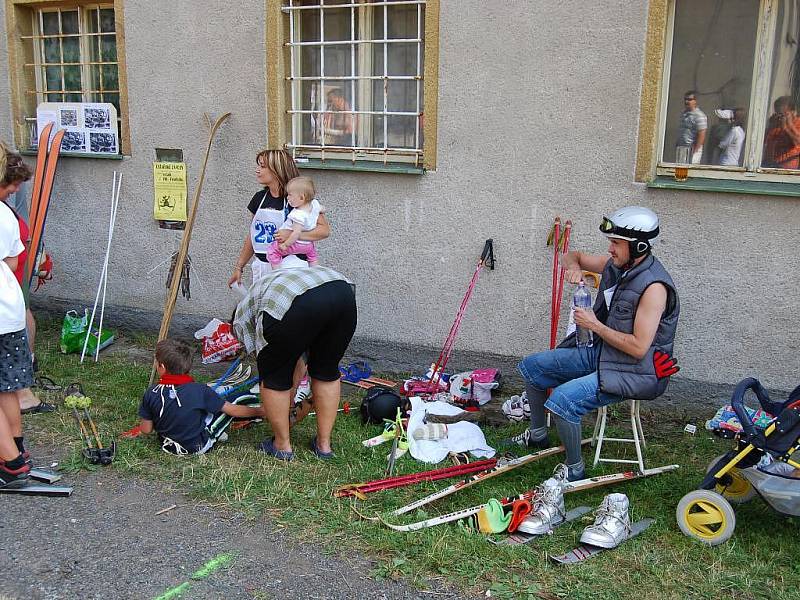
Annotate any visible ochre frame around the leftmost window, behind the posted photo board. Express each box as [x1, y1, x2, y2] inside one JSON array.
[[6, 0, 131, 158]]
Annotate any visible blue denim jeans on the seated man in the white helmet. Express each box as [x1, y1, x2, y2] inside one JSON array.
[[517, 344, 623, 424]]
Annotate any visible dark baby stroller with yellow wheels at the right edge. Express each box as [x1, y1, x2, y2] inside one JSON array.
[[675, 377, 800, 546]]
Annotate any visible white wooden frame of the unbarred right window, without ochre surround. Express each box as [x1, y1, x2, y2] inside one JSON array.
[[655, 0, 800, 183]]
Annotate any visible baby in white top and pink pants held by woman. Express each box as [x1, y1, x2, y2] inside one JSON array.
[[267, 177, 325, 270]]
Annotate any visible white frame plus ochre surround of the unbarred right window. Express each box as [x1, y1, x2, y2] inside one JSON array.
[[634, 0, 800, 185]]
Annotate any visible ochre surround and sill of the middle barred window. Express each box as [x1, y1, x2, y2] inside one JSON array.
[[266, 0, 439, 173]]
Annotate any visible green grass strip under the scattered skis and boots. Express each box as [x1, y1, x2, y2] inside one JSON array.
[[21, 323, 800, 600]]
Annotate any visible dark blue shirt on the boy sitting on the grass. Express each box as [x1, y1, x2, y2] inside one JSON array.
[[139, 382, 225, 452]]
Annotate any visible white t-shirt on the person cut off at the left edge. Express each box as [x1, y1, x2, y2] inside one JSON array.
[[0, 202, 25, 335]]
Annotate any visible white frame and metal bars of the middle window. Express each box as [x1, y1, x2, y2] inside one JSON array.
[[281, 0, 427, 167]]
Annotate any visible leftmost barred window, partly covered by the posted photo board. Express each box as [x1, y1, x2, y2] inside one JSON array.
[[8, 0, 129, 151]]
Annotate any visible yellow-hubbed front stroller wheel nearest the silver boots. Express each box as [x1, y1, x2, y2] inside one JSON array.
[[675, 490, 736, 546]]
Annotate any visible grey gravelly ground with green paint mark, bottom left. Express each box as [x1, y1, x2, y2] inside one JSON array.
[[0, 440, 463, 600]]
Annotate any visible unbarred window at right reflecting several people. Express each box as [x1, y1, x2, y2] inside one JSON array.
[[648, 0, 800, 182]]
